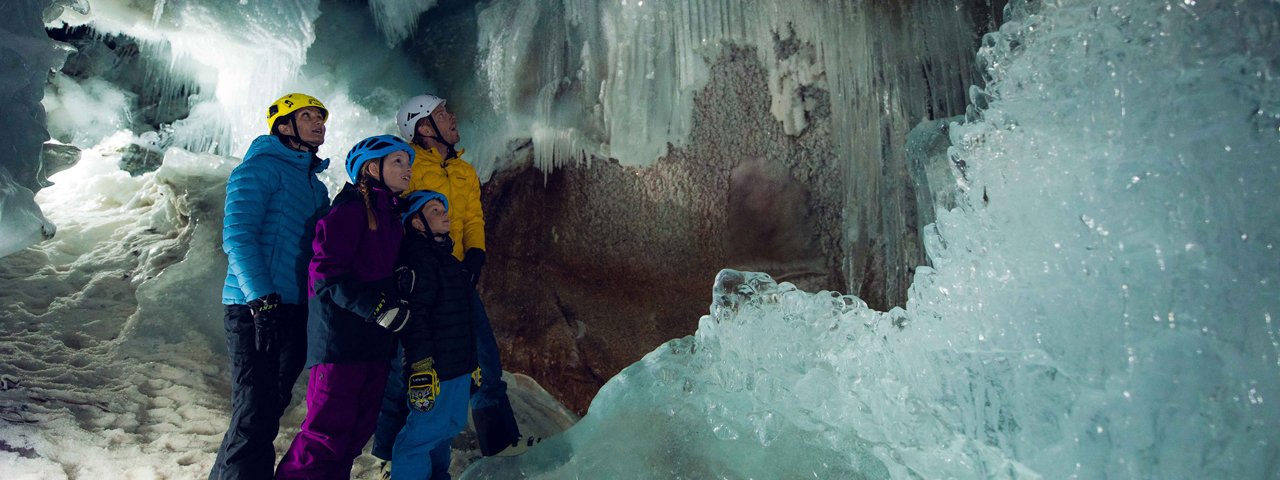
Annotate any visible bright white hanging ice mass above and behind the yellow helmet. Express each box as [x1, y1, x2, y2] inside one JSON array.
[[54, 0, 320, 155]]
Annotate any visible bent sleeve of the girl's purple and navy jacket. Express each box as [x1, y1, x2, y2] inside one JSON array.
[[310, 207, 396, 319]]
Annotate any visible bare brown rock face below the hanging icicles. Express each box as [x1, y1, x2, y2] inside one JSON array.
[[480, 50, 844, 413]]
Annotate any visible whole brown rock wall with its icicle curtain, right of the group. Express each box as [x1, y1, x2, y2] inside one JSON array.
[[480, 1, 998, 411]]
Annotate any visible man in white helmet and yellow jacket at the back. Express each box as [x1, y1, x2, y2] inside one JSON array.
[[372, 95, 539, 476]]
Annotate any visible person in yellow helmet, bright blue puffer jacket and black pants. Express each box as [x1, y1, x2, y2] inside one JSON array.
[[209, 93, 329, 479]]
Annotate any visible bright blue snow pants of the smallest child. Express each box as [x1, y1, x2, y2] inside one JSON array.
[[392, 375, 471, 480]]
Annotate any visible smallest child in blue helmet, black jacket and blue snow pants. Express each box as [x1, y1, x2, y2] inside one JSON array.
[[390, 191, 477, 480]]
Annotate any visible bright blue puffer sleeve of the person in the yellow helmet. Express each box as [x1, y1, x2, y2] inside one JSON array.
[[223, 161, 279, 300]]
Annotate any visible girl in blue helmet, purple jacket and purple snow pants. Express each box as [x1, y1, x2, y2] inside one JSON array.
[[276, 136, 413, 479]]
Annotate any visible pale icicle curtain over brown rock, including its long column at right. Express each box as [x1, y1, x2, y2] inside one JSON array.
[[475, 0, 977, 306]]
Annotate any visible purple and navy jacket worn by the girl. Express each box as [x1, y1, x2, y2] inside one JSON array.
[[307, 183, 404, 367]]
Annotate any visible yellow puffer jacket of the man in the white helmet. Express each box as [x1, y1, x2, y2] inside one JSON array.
[[408, 143, 484, 260]]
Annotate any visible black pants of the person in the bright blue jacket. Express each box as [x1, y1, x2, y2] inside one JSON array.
[[209, 305, 307, 480]]
